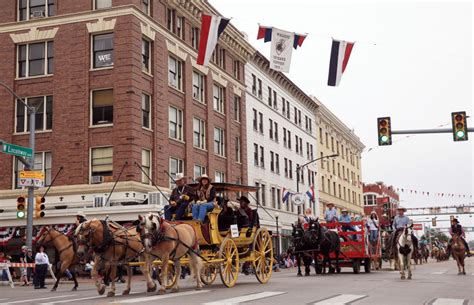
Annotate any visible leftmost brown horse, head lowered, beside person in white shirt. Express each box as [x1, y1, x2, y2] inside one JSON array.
[[36, 226, 80, 291]]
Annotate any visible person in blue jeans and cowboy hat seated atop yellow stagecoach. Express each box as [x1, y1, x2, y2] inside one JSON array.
[[192, 174, 217, 222]]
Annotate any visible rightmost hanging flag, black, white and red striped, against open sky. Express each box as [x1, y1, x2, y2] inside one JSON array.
[[328, 39, 354, 87]]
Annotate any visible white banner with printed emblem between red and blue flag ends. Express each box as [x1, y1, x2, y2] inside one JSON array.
[[257, 26, 306, 72]]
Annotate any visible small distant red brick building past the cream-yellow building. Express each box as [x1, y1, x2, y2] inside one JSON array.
[[364, 182, 400, 219]]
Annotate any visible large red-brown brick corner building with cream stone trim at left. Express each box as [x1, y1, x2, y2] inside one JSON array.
[[0, 0, 255, 225]]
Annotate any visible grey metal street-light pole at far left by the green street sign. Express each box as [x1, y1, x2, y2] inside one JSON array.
[[0, 81, 36, 249]]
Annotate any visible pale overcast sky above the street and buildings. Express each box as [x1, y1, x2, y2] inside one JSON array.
[[213, 0, 474, 213]]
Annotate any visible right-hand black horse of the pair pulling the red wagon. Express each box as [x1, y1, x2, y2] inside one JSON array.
[[305, 219, 341, 274]]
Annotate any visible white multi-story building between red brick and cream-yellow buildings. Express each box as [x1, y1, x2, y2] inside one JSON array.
[[245, 52, 318, 250]]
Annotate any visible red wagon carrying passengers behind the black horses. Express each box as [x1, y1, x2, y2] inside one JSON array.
[[320, 220, 382, 273]]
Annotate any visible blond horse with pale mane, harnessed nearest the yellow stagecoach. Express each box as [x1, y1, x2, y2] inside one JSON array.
[[137, 213, 202, 294]]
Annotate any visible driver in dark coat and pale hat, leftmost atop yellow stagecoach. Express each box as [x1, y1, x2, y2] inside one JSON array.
[[165, 173, 196, 220]]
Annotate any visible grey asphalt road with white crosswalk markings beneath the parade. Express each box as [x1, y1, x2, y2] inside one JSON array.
[[0, 258, 474, 305]]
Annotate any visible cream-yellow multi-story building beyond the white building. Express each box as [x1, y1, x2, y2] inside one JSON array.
[[313, 98, 365, 217]]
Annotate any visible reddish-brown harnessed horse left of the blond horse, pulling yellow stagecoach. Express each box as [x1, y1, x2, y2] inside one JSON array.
[[75, 219, 156, 297]]
